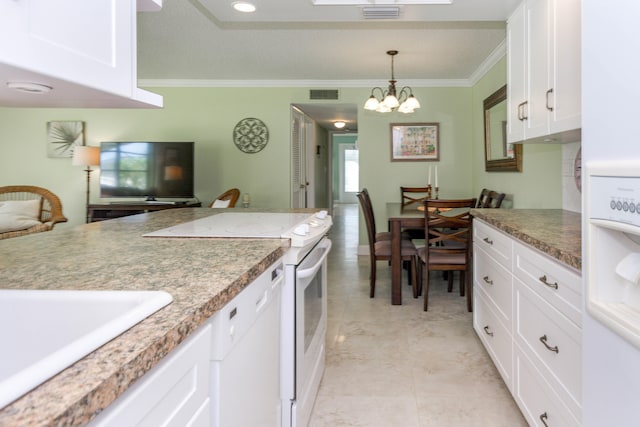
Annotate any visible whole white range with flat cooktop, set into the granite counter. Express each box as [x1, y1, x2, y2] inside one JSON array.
[[146, 209, 333, 427]]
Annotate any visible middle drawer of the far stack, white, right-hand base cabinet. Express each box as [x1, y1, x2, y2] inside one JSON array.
[[473, 245, 513, 333]]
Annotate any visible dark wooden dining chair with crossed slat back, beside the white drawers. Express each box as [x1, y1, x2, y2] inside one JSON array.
[[417, 198, 476, 311]]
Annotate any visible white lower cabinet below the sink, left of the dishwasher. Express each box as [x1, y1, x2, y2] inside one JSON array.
[[89, 325, 211, 427]]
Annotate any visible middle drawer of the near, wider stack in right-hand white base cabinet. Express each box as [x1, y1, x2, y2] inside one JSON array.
[[513, 279, 582, 413]]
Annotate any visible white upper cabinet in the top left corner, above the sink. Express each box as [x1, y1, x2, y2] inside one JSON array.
[[0, 0, 162, 107]]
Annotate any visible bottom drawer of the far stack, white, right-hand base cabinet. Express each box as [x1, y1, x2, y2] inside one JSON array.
[[473, 289, 513, 390]]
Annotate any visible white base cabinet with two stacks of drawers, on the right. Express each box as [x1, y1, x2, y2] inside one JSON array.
[[473, 219, 582, 427]]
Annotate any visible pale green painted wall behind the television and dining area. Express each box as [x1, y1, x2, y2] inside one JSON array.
[[0, 69, 562, 234]]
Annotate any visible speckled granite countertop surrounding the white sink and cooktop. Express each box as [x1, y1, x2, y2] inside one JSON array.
[[0, 208, 313, 426]]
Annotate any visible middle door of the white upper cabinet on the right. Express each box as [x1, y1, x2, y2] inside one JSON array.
[[525, 0, 549, 139]]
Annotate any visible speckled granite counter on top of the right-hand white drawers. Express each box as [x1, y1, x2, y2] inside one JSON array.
[[471, 209, 582, 271]]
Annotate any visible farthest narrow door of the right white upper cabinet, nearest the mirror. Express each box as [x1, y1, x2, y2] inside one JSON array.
[[507, 2, 527, 142]]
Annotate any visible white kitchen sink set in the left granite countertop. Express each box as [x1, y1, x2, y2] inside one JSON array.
[[0, 289, 173, 408]]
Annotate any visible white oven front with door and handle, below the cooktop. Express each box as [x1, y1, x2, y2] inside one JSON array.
[[281, 237, 331, 427]]
